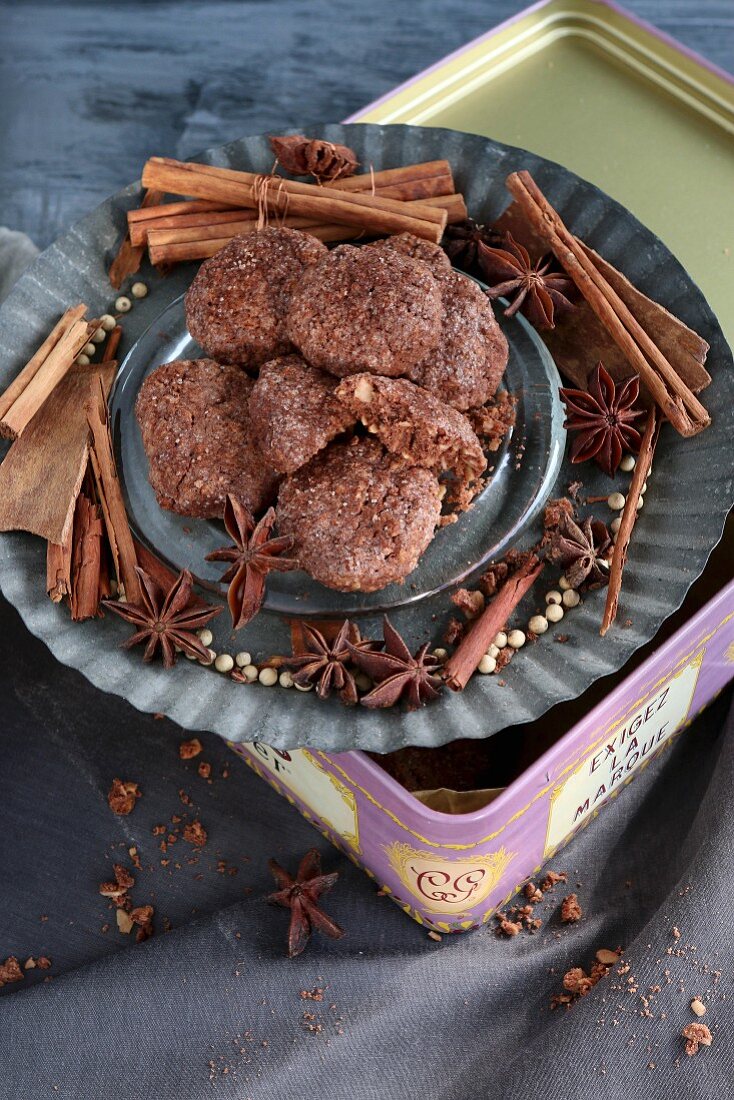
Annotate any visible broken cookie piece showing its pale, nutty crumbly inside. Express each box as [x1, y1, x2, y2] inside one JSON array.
[[337, 374, 486, 507]]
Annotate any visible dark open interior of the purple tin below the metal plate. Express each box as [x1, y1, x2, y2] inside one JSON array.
[[370, 512, 734, 814]]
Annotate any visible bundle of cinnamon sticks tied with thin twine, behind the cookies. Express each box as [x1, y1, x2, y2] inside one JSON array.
[[116, 157, 467, 267]]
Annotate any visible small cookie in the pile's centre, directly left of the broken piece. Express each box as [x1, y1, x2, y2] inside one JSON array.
[[250, 355, 354, 474]]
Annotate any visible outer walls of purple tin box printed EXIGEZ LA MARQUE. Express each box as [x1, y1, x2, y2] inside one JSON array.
[[230, 582, 734, 932]]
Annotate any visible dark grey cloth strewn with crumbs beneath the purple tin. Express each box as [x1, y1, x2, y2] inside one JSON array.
[[0, 607, 734, 1100]]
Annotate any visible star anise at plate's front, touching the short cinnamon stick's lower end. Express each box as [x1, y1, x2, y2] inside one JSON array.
[[347, 615, 441, 711]]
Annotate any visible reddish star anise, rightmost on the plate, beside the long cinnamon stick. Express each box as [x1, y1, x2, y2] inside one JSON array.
[[560, 363, 644, 477]]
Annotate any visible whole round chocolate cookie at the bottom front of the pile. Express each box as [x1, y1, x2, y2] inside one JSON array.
[[277, 438, 441, 592]]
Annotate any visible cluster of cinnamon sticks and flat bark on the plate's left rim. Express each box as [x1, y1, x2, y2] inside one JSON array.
[[0, 314, 145, 620]]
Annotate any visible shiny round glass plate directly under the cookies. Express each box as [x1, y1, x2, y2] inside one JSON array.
[[110, 276, 566, 618]]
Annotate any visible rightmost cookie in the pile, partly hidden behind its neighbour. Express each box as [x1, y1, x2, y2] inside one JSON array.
[[405, 271, 507, 410]]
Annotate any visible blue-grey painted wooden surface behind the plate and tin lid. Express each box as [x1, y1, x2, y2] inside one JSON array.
[[0, 0, 734, 248]]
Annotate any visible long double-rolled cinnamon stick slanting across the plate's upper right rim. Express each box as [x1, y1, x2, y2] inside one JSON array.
[[506, 172, 711, 437]]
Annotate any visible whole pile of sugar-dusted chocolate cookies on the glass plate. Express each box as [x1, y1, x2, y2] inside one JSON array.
[[136, 228, 507, 592]]
